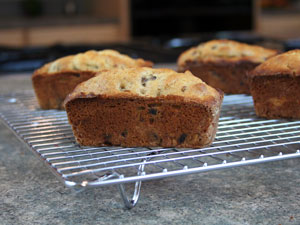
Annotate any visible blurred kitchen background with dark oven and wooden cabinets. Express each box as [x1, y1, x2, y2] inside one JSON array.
[[0, 0, 300, 74]]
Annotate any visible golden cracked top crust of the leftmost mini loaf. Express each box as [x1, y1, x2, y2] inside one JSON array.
[[34, 50, 152, 74]]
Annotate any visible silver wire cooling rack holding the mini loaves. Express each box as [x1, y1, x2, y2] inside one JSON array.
[[0, 91, 300, 208]]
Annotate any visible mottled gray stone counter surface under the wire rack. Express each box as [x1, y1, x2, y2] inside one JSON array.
[[0, 75, 300, 225]]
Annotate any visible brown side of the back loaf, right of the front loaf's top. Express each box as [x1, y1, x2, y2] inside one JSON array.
[[179, 61, 258, 94]]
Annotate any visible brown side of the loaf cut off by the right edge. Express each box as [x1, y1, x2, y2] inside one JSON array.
[[250, 75, 300, 119]]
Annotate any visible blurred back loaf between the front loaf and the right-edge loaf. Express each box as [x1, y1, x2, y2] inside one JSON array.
[[177, 40, 277, 94]]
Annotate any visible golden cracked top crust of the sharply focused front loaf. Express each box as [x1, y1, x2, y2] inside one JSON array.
[[65, 67, 223, 104]]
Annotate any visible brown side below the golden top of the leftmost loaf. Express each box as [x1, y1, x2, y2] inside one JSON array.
[[32, 72, 95, 109]]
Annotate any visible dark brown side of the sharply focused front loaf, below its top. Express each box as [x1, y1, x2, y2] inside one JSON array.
[[66, 97, 222, 148]]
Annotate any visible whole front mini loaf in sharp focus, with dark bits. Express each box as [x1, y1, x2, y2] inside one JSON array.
[[65, 67, 223, 148]]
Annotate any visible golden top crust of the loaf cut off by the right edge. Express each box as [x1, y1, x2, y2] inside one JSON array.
[[251, 49, 300, 76]]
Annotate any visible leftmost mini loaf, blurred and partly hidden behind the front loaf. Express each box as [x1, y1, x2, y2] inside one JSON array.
[[32, 50, 152, 109]]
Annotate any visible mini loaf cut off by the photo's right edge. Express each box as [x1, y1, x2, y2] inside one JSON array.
[[250, 50, 300, 118]]
